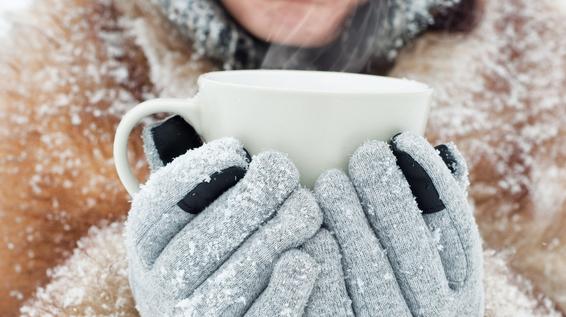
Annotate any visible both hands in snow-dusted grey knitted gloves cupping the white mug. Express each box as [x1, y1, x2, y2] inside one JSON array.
[[126, 117, 483, 316]]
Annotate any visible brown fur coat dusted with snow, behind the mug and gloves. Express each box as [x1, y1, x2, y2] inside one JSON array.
[[0, 0, 566, 316]]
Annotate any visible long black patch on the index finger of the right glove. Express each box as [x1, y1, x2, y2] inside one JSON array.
[[390, 138, 446, 214]]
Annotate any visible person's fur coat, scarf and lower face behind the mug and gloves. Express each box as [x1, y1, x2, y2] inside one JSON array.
[[0, 0, 566, 316]]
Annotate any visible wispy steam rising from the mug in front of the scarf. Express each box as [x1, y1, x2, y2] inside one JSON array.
[[261, 0, 460, 73]]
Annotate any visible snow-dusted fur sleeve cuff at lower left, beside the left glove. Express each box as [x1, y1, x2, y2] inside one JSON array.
[[21, 223, 137, 317]]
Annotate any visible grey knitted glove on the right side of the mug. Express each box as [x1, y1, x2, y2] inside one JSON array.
[[316, 133, 483, 317]]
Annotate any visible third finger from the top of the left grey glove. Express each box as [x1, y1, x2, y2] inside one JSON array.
[[176, 189, 322, 316]]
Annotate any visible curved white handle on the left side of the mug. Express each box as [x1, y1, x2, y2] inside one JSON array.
[[113, 98, 200, 196]]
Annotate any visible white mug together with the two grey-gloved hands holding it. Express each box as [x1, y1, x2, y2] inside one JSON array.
[[114, 70, 483, 317]]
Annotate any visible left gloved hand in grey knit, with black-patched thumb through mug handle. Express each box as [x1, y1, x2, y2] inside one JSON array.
[[126, 117, 322, 317]]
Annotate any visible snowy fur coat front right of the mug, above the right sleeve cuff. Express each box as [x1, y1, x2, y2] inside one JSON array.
[[393, 0, 566, 310]]
